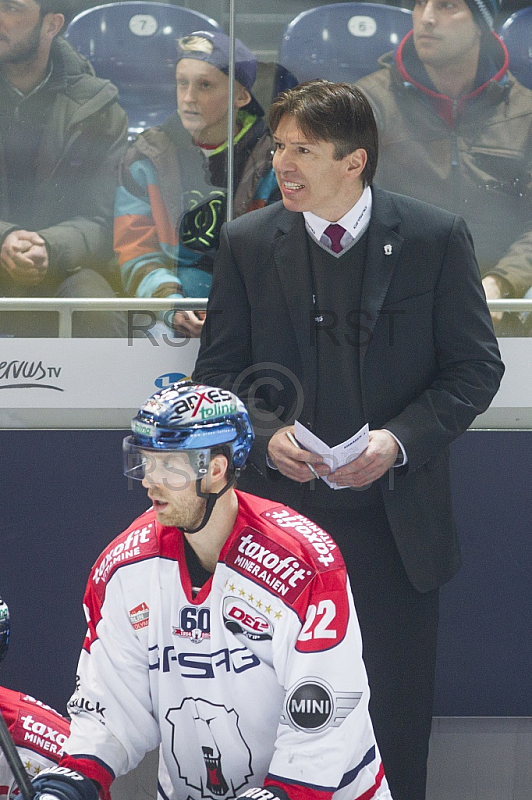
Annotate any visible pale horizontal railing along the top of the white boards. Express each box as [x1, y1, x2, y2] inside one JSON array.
[[0, 297, 532, 338]]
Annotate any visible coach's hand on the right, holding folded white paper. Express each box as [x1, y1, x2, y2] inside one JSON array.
[[329, 430, 399, 489]]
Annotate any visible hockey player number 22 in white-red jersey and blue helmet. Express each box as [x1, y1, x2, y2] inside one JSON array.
[[34, 381, 391, 800]]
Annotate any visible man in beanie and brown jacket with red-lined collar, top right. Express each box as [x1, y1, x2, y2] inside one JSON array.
[[357, 0, 532, 335]]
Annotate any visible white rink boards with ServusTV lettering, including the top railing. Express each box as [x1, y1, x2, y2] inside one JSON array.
[[0, 298, 532, 430]]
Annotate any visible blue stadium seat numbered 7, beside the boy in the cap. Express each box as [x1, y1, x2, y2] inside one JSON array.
[[65, 0, 220, 137]]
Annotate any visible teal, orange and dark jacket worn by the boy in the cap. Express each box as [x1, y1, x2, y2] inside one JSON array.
[[114, 111, 280, 298]]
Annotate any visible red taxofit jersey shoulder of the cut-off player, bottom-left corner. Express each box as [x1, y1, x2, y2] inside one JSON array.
[[0, 686, 70, 800]]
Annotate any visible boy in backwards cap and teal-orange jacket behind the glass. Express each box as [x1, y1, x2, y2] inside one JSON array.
[[114, 31, 280, 336]]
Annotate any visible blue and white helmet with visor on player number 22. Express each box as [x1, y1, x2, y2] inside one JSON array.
[[123, 380, 255, 480]]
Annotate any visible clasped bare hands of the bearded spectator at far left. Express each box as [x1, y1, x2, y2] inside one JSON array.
[[0, 230, 49, 286]]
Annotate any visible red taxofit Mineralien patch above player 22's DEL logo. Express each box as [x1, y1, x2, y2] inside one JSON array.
[[226, 527, 313, 605]]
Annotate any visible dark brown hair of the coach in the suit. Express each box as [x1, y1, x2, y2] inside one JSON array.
[[269, 79, 379, 186]]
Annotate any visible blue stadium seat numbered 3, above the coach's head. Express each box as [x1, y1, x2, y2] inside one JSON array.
[[279, 3, 412, 90]]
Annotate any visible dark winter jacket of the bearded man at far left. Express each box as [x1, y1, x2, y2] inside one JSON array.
[[0, 38, 127, 283]]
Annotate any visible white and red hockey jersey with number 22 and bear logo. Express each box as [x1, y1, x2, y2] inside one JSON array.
[[61, 492, 391, 800]]
